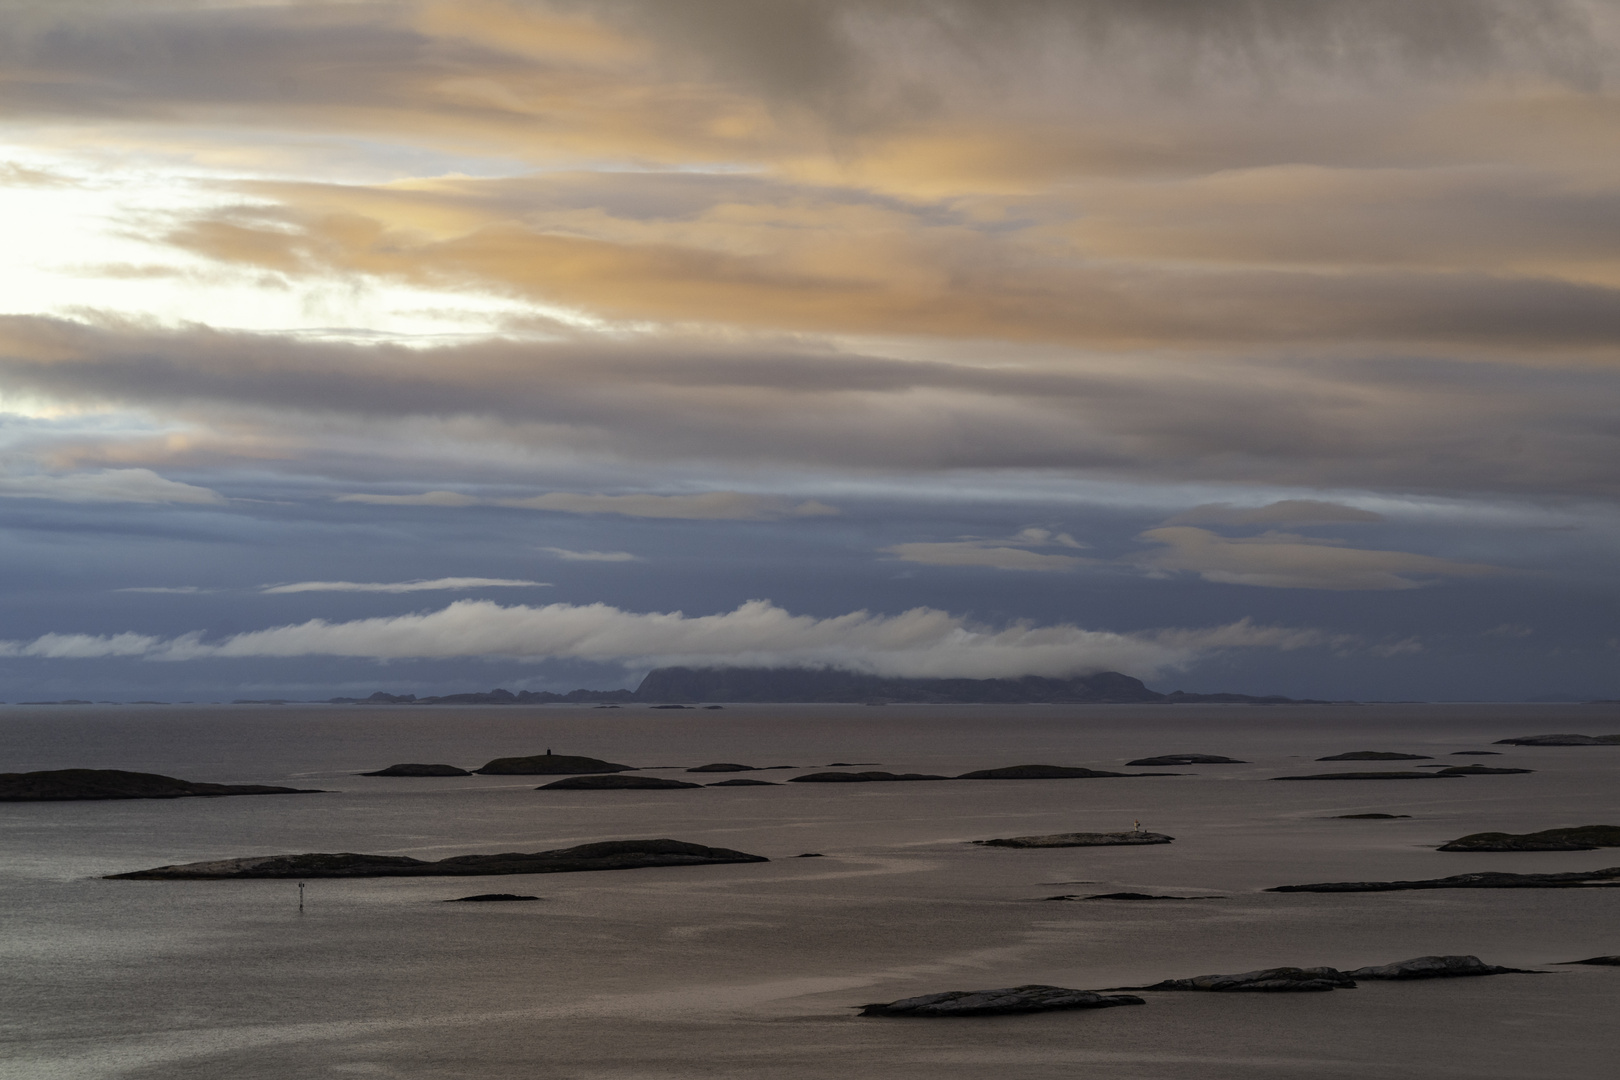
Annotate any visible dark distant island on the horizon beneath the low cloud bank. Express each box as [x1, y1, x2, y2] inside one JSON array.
[[329, 667, 1332, 704]]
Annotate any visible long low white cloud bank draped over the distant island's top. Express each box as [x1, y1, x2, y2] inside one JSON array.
[[0, 601, 1341, 678]]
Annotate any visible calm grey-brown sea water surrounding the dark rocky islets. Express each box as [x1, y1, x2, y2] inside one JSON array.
[[0, 706, 1620, 1080]]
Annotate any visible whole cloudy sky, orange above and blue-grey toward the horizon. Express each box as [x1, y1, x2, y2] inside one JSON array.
[[0, 0, 1620, 701]]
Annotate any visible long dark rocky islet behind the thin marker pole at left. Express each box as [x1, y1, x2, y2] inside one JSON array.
[[107, 840, 770, 881]]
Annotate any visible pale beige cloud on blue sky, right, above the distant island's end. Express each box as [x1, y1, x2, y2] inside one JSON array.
[[1128, 525, 1505, 591]]
